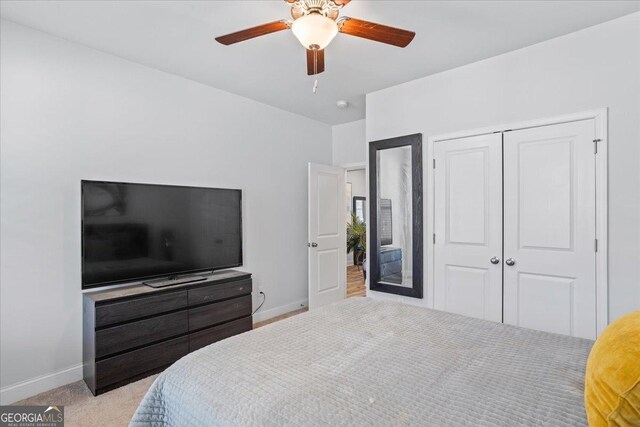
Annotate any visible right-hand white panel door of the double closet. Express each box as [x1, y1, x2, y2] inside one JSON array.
[[504, 120, 596, 339]]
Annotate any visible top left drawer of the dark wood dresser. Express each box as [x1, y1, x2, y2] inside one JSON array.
[[96, 290, 187, 328]]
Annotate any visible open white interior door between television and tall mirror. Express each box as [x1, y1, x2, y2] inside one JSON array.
[[308, 163, 347, 309]]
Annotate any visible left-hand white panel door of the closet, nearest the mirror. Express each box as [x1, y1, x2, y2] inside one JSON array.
[[434, 134, 502, 322]]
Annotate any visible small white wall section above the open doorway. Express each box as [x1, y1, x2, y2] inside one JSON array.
[[332, 120, 367, 166]]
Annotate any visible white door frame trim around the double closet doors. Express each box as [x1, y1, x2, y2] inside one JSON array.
[[423, 107, 609, 336]]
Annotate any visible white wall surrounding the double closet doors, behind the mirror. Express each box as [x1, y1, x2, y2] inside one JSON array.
[[364, 13, 640, 320]]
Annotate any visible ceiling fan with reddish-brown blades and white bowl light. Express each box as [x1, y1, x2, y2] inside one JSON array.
[[216, 0, 416, 75]]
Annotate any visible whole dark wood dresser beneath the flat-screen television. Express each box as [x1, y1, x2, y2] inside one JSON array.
[[82, 270, 252, 395]]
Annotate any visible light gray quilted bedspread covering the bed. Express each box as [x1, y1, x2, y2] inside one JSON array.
[[131, 298, 593, 427]]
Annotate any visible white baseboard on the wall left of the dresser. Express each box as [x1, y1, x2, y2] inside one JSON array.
[[0, 363, 82, 405]]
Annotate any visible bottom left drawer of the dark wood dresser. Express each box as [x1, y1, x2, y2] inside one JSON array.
[[96, 336, 189, 389]]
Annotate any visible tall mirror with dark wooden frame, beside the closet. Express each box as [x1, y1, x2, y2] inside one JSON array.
[[368, 134, 422, 298]]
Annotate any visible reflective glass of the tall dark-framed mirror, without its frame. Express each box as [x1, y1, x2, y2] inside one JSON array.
[[376, 146, 413, 288]]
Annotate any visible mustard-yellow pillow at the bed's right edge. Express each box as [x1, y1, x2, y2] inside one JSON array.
[[584, 310, 640, 427]]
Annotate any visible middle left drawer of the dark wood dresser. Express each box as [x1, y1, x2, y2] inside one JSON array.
[[96, 310, 189, 358]]
